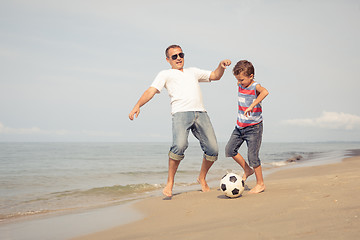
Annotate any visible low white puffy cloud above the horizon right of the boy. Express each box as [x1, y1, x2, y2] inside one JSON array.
[[282, 111, 360, 130]]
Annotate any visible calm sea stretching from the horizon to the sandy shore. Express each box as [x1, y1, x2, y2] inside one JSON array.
[[0, 142, 360, 237]]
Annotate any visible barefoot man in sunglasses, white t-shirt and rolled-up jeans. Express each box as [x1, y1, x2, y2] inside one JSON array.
[[129, 45, 231, 197]]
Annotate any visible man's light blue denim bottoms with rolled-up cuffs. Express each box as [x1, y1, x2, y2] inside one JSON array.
[[169, 111, 219, 162]]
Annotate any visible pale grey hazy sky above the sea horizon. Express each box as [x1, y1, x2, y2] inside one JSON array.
[[0, 0, 360, 142]]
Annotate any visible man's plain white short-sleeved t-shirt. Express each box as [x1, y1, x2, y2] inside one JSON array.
[[151, 68, 211, 114]]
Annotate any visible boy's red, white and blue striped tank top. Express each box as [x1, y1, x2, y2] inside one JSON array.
[[237, 82, 263, 128]]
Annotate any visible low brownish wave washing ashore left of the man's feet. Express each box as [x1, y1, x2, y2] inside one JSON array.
[[0, 183, 164, 221]]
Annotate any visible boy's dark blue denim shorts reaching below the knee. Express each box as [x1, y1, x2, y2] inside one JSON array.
[[225, 122, 263, 167]]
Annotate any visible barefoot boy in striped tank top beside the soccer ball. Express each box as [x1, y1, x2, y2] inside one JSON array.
[[225, 60, 269, 193]]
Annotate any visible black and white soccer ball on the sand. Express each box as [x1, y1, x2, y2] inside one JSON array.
[[220, 173, 245, 198]]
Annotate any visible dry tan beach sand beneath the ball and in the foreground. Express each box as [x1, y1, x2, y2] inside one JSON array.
[[76, 157, 360, 240]]
